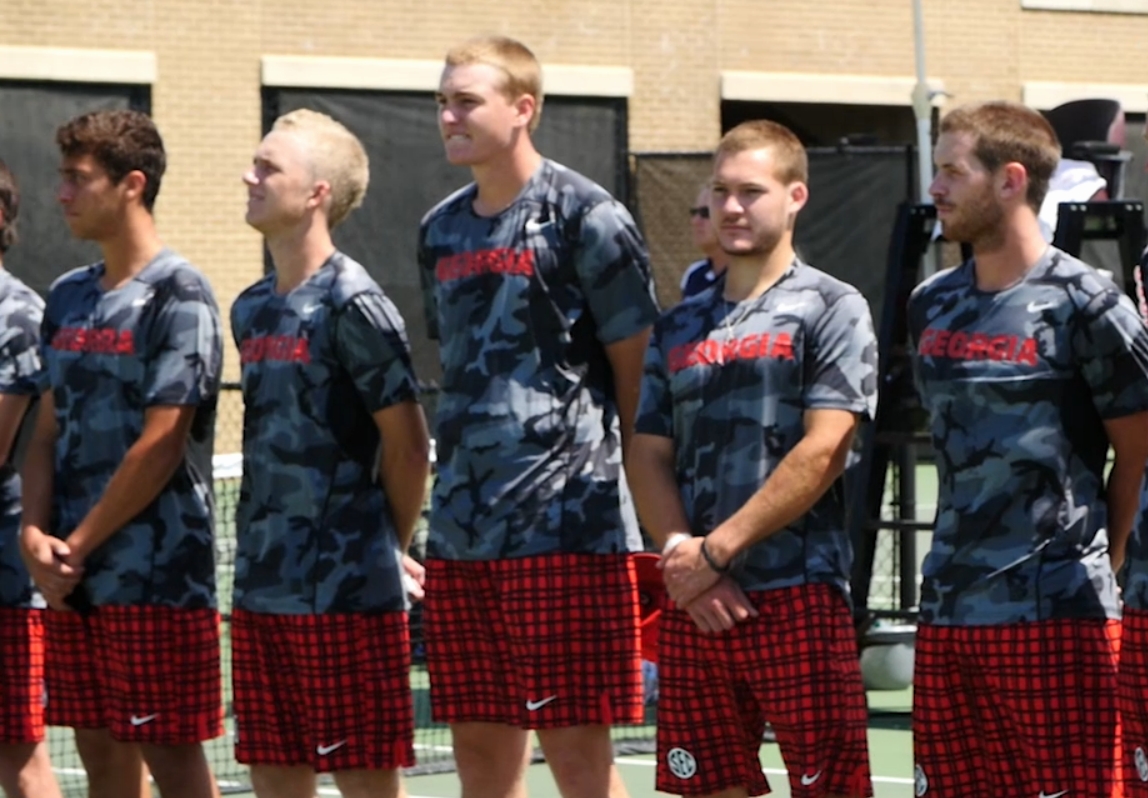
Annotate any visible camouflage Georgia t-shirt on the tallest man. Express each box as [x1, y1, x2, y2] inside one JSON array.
[[419, 161, 658, 560]]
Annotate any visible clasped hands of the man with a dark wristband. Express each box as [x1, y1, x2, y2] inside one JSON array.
[[658, 535, 758, 634]]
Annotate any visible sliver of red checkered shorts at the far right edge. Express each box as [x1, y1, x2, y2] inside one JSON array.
[[1119, 607, 1148, 798]]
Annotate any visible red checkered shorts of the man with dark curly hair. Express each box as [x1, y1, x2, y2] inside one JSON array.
[[44, 605, 223, 745]]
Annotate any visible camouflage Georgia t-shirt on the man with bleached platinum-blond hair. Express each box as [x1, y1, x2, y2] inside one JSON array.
[[231, 253, 416, 614]]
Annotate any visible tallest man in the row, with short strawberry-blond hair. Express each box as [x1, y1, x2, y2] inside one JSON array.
[[419, 38, 657, 798]]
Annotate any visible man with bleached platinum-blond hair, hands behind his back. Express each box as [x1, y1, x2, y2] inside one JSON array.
[[231, 110, 428, 798]]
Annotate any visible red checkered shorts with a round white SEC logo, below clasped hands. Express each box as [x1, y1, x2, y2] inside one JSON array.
[[657, 584, 872, 798]]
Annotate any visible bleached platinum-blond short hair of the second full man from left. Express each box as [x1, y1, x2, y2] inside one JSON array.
[[271, 108, 371, 230]]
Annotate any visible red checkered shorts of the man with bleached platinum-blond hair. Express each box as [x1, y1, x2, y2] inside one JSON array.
[[231, 610, 414, 773]]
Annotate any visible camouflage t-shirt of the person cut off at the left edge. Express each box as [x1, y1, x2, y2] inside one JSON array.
[[0, 269, 45, 607]]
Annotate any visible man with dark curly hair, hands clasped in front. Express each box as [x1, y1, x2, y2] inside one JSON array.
[[22, 110, 223, 798]]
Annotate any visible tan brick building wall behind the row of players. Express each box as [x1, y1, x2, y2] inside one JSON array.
[[0, 0, 1148, 319]]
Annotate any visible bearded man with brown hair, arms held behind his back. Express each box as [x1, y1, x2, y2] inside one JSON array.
[[909, 102, 1148, 798]]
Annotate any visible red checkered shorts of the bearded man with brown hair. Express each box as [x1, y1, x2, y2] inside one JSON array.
[[913, 619, 1120, 798]]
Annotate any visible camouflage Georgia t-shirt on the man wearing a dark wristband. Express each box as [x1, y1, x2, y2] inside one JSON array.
[[637, 262, 877, 595]]
